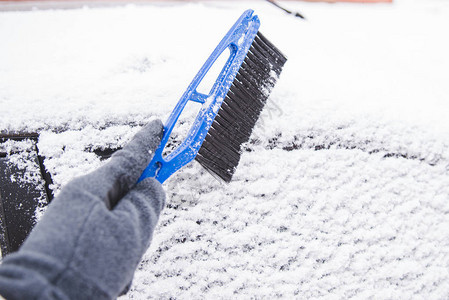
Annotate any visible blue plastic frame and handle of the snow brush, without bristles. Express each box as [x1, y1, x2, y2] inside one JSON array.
[[138, 10, 260, 183]]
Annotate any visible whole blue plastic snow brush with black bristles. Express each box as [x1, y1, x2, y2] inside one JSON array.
[[139, 10, 287, 183]]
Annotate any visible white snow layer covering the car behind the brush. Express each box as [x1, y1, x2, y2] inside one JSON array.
[[0, 0, 449, 299]]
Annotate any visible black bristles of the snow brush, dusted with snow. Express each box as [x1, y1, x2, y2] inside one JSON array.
[[195, 32, 287, 182]]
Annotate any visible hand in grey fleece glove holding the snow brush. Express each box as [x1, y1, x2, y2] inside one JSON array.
[[0, 120, 165, 299]]
